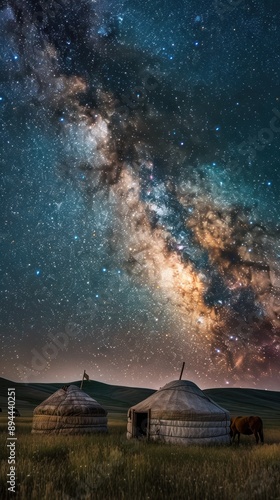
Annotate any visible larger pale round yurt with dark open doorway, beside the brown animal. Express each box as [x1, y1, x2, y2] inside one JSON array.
[[127, 380, 230, 445]]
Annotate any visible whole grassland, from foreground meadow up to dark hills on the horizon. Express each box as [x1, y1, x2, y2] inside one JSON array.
[[0, 381, 280, 500]]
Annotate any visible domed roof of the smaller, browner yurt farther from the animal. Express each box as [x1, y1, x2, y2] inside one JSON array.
[[33, 385, 107, 416]]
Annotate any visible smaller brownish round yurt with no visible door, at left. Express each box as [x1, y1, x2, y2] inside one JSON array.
[[32, 385, 107, 434]]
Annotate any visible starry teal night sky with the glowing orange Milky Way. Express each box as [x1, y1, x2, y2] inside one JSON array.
[[0, 0, 280, 390]]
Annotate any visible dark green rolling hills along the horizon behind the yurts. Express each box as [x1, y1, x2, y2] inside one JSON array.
[[0, 378, 280, 427]]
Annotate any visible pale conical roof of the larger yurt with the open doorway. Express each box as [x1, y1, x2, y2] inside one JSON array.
[[130, 380, 229, 420]]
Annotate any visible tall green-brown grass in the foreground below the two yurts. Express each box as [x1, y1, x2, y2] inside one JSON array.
[[0, 419, 280, 500]]
